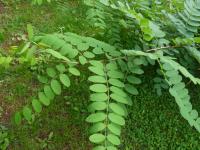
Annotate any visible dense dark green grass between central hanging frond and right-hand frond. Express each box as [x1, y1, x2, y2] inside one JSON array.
[[123, 81, 200, 150]]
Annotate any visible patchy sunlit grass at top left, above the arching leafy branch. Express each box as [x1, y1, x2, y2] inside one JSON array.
[[0, 0, 94, 48]]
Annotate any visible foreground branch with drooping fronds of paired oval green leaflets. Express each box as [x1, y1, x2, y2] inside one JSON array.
[[11, 30, 200, 149]]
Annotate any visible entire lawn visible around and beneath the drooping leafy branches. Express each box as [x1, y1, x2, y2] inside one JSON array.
[[0, 0, 200, 150]]
